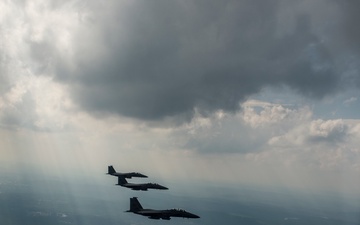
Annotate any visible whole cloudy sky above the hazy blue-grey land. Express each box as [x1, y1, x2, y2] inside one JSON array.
[[0, 0, 360, 199]]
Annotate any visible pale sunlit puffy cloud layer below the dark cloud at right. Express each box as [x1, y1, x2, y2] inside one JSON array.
[[172, 100, 360, 176]]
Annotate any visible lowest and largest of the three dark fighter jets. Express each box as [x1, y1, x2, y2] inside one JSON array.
[[125, 197, 200, 220]]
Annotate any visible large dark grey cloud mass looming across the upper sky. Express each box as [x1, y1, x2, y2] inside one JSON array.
[[45, 0, 359, 121]]
